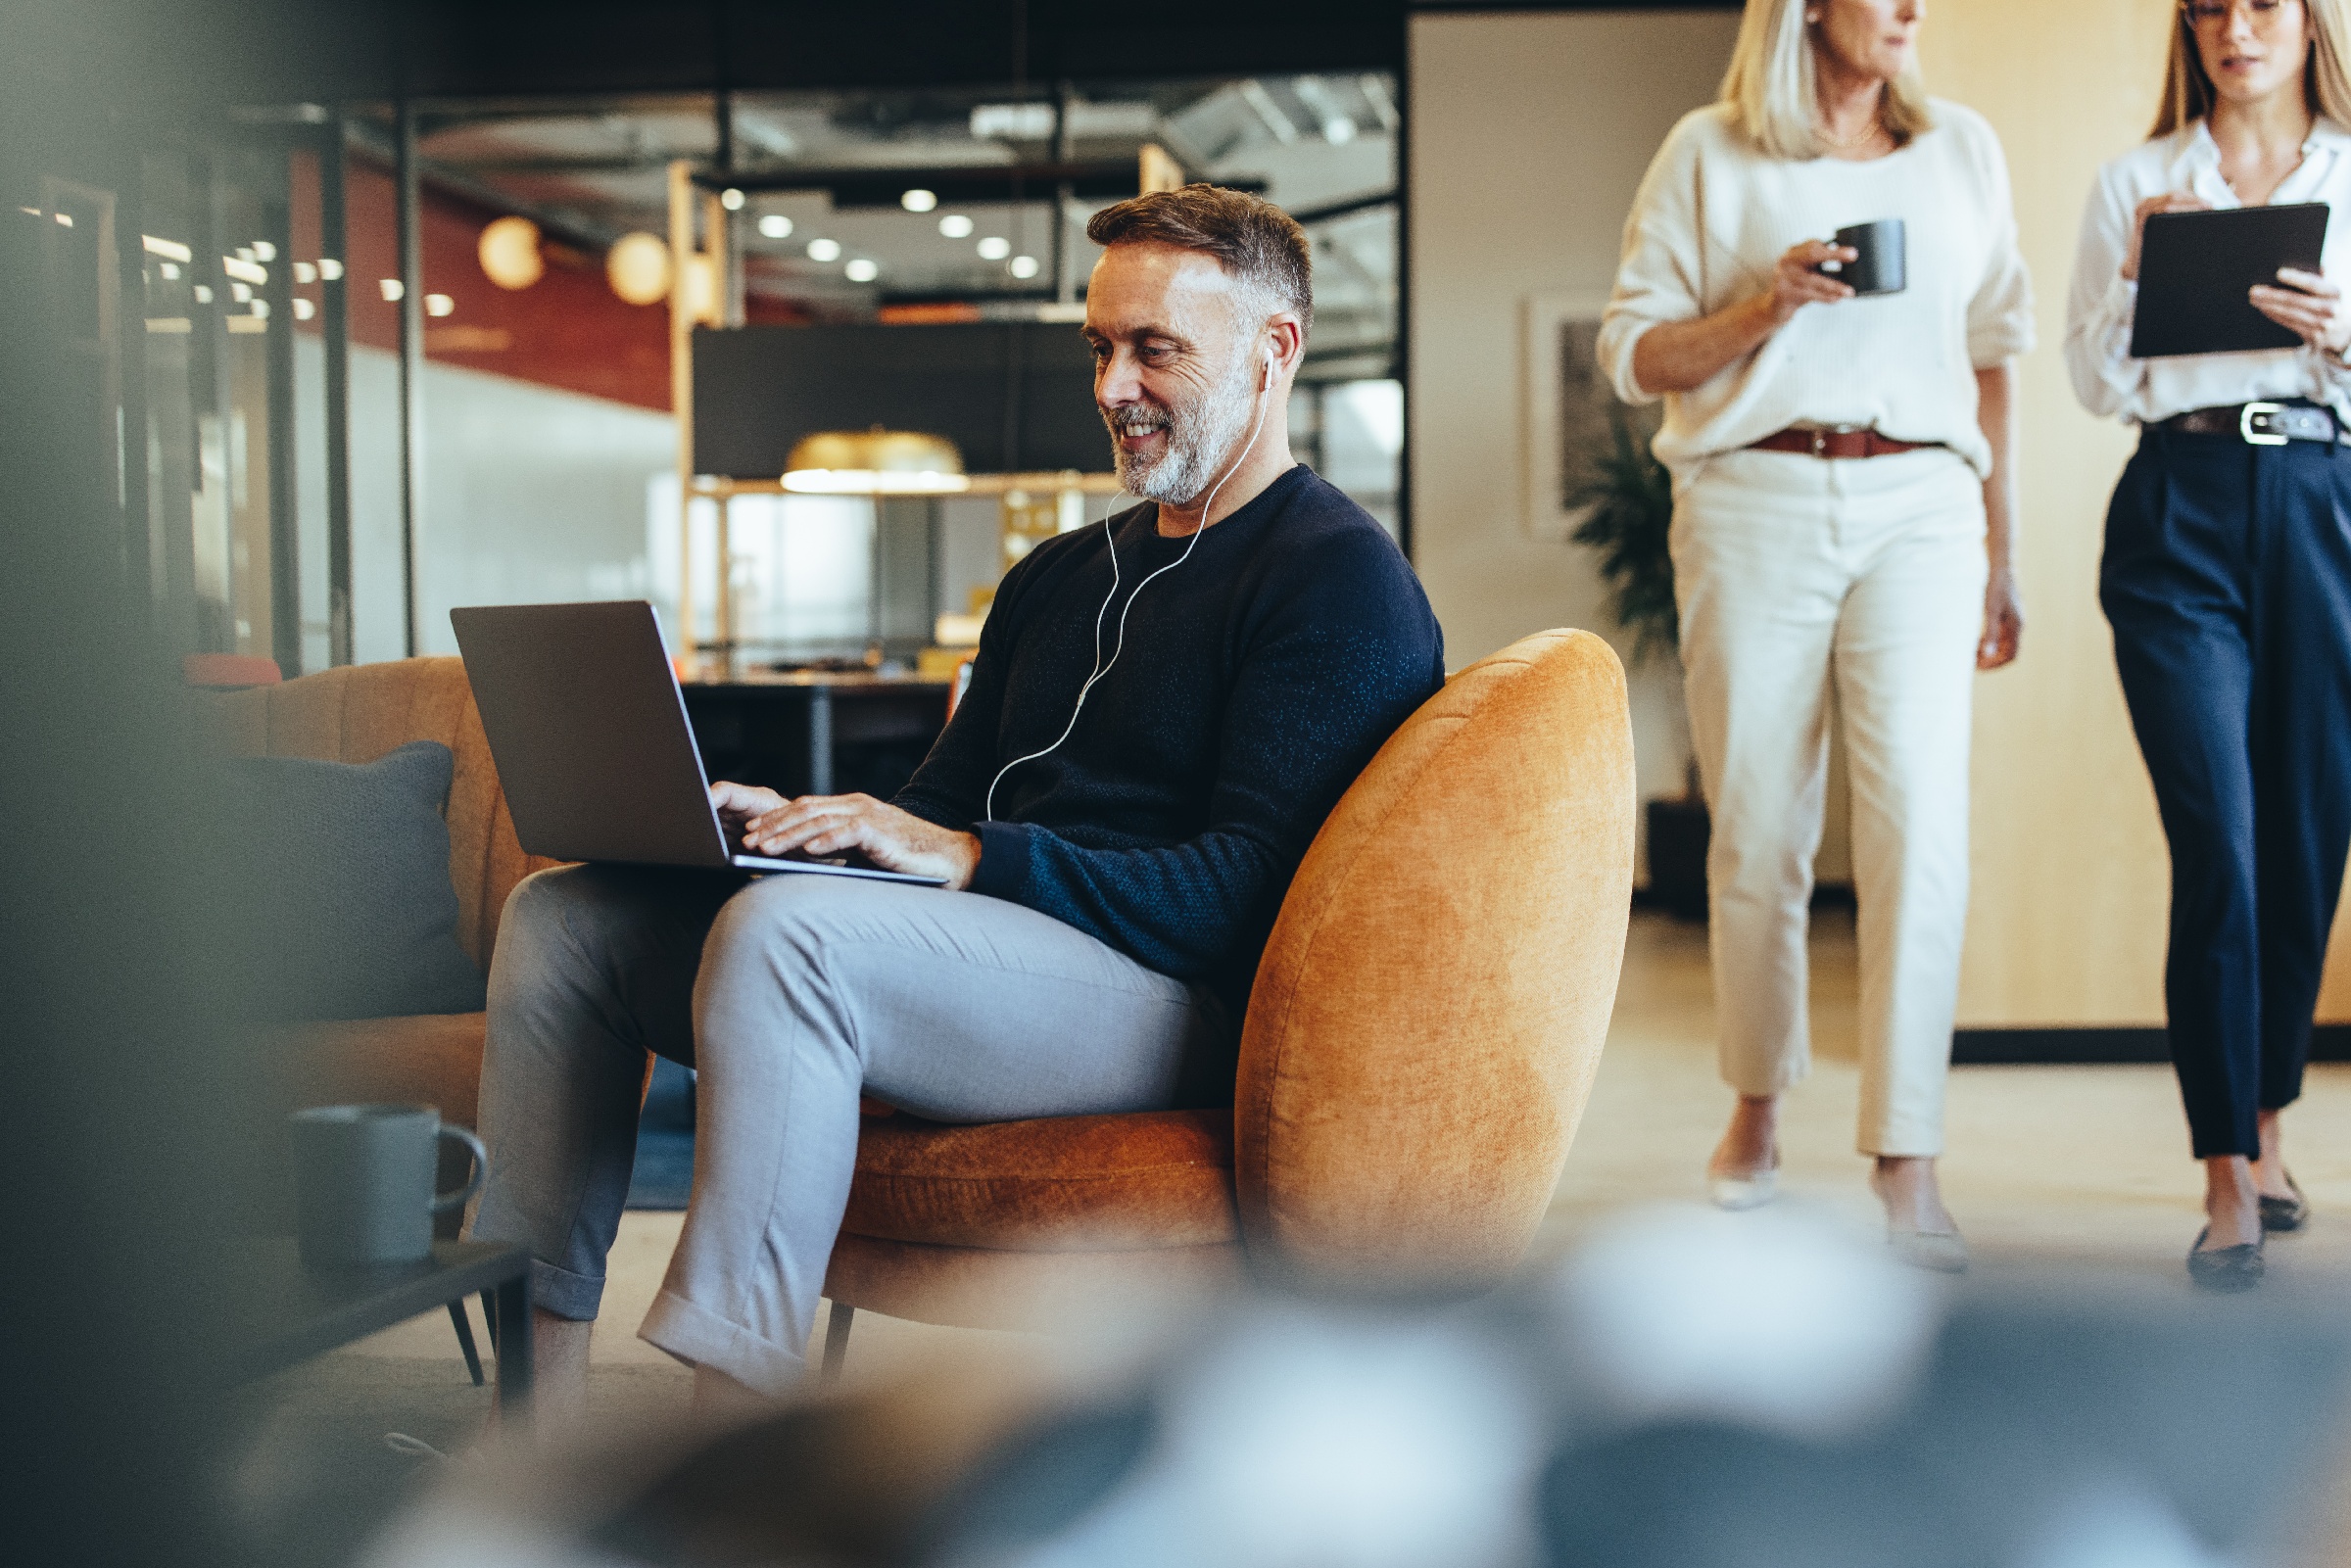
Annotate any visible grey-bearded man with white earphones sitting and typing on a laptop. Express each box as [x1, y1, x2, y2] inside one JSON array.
[[475, 186, 1444, 1420]]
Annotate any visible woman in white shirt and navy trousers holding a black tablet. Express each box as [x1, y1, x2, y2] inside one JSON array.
[[2067, 0, 2351, 1291]]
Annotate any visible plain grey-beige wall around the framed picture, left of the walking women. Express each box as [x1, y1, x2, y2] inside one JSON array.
[[1411, 12, 1738, 846]]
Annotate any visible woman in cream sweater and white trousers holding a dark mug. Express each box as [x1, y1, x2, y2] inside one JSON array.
[[1599, 0, 2032, 1269]]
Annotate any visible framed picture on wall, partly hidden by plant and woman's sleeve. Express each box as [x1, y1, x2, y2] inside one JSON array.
[[1518, 289, 1657, 543]]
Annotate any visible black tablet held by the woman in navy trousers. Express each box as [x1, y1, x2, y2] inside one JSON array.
[[2130, 202, 2327, 359]]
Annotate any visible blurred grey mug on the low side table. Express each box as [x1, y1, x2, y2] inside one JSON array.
[[294, 1105, 489, 1267]]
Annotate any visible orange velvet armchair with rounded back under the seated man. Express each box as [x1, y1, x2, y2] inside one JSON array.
[[825, 633, 1634, 1368]]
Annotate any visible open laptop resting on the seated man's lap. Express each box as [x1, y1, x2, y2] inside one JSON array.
[[449, 599, 945, 886]]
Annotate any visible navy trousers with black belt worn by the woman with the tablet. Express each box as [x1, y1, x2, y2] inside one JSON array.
[[2099, 428, 2351, 1159]]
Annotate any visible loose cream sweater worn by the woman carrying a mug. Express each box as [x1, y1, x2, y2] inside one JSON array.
[[1599, 99, 2034, 477]]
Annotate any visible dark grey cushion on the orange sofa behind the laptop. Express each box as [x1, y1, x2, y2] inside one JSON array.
[[228, 740, 484, 1018]]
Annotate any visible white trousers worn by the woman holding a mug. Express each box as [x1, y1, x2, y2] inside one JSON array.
[[1671, 449, 1987, 1155]]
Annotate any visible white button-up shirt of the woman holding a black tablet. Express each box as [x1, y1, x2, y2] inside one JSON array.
[[2064, 119, 2351, 423]]
